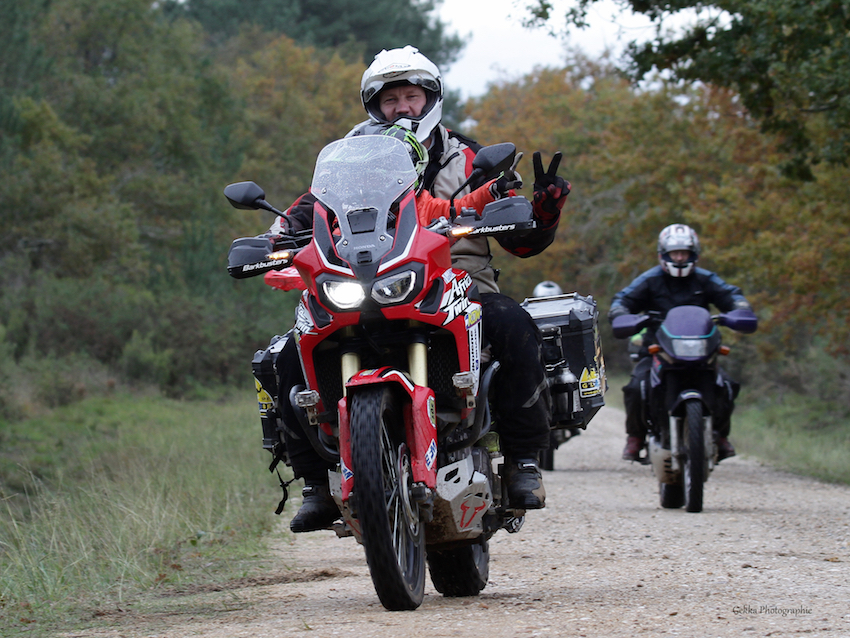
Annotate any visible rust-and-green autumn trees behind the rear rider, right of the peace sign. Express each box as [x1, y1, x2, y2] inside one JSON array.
[[469, 58, 850, 376]]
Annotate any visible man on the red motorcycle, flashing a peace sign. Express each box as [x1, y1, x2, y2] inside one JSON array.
[[270, 46, 570, 532]]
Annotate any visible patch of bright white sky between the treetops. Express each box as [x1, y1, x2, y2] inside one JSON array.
[[438, 0, 664, 98]]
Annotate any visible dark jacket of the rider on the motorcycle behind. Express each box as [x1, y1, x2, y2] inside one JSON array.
[[608, 266, 751, 330]]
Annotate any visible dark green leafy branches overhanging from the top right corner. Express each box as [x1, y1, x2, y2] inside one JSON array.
[[527, 0, 850, 180]]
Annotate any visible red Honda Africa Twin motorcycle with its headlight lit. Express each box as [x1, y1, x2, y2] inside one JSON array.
[[225, 136, 548, 610]]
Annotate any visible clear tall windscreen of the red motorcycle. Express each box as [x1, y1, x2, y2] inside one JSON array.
[[310, 135, 417, 263]]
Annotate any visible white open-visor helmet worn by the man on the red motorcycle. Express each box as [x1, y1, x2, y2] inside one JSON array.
[[360, 44, 443, 143]]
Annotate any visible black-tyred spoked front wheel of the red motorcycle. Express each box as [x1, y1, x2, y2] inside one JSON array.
[[350, 387, 425, 611]]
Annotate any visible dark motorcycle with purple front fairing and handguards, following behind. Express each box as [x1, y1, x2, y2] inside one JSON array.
[[612, 306, 758, 512]]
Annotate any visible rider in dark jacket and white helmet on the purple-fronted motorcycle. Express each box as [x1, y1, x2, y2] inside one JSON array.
[[608, 224, 752, 461]]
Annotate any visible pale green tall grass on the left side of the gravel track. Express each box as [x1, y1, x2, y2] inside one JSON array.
[[0, 393, 288, 636]]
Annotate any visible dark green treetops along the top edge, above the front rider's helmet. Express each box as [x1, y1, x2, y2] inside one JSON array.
[[168, 0, 463, 66]]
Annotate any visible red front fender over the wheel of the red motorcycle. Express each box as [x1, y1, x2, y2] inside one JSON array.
[[338, 368, 437, 501]]
